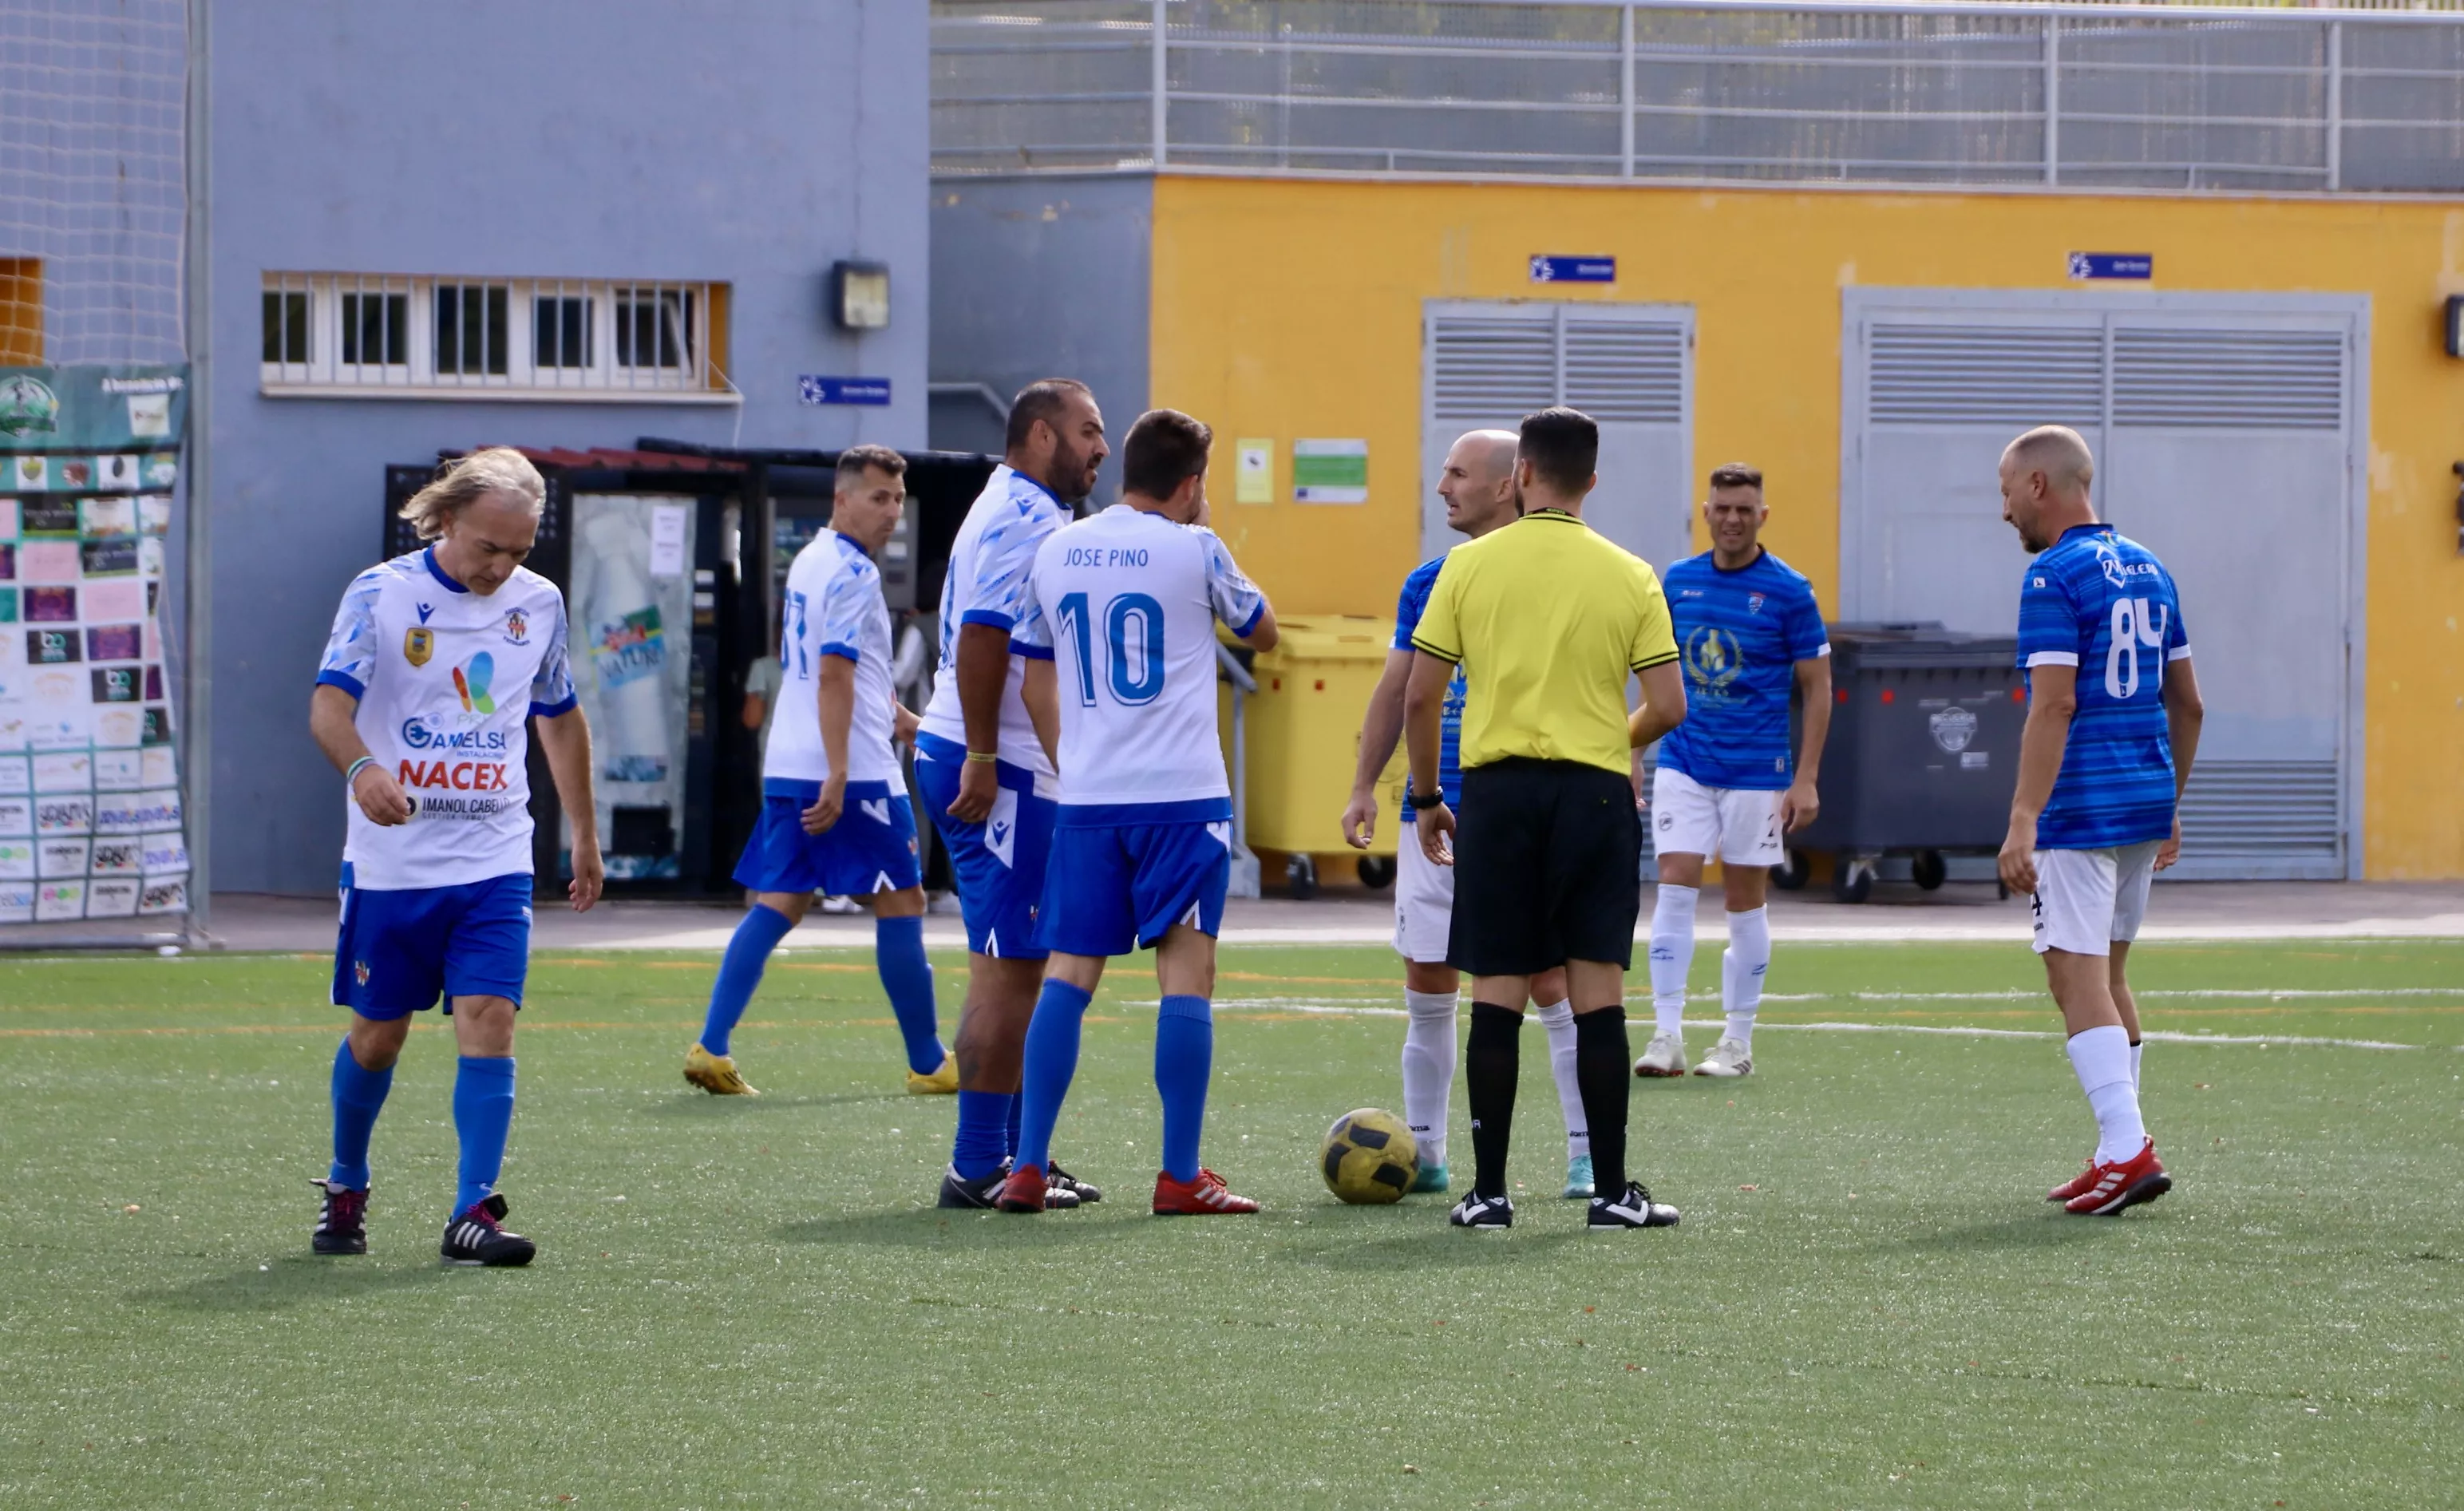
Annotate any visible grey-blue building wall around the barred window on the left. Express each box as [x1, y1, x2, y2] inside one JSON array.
[[209, 0, 929, 892]]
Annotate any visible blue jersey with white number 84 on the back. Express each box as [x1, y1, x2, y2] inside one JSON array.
[[2018, 525, 2190, 850]]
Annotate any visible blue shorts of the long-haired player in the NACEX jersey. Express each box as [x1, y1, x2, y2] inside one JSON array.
[[333, 865, 530, 1023]]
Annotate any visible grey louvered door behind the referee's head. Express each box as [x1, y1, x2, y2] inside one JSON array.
[[1419, 303, 1693, 567]]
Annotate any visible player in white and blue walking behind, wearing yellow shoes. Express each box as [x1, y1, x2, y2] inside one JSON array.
[[685, 446, 959, 1097]]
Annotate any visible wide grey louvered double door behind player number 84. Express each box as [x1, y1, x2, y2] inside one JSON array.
[[1841, 288, 2368, 877]]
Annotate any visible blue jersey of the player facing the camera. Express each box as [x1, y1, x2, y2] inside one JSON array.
[[1661, 552, 1831, 791]]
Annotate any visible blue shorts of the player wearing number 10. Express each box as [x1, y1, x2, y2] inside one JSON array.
[[1038, 821, 1232, 956]]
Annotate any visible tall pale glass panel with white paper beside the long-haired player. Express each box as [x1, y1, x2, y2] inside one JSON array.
[[564, 493, 692, 880]]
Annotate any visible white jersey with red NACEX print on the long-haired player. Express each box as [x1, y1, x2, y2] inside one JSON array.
[[315, 548, 574, 892]]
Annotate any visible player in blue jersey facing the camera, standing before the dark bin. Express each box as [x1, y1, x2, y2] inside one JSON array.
[[1634, 464, 1831, 1077]]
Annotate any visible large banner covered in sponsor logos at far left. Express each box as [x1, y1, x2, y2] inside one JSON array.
[[0, 365, 188, 929]]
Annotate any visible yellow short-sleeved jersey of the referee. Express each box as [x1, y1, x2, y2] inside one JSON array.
[[1412, 510, 1678, 772]]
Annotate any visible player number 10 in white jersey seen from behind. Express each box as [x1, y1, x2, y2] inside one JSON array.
[[1000, 409, 1276, 1215]]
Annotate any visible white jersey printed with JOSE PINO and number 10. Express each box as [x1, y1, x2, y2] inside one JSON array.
[[1015, 503, 1267, 823]]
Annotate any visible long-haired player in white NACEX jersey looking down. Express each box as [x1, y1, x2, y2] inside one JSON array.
[[308, 449, 603, 1264]]
